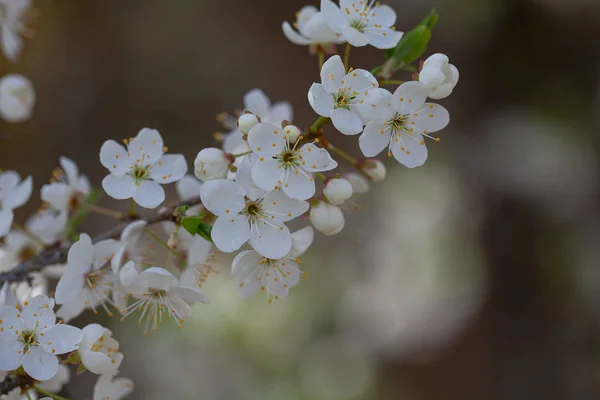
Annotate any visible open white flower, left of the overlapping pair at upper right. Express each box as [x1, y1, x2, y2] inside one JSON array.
[[308, 56, 379, 135]]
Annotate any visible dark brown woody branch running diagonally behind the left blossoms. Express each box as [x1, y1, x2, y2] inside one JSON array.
[[0, 197, 201, 286]]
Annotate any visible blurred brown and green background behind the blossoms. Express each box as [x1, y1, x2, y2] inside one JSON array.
[[0, 0, 600, 400]]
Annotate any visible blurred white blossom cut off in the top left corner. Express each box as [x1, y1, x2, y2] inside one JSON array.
[[0, 0, 31, 62]]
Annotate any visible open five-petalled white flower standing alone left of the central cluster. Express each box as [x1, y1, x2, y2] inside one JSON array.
[[100, 128, 187, 209]]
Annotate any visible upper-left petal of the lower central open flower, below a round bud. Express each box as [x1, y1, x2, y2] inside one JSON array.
[[200, 179, 246, 216]]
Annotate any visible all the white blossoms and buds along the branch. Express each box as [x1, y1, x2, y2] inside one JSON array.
[[0, 0, 459, 400]]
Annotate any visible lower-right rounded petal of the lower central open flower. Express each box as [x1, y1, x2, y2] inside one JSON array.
[[250, 220, 292, 259]]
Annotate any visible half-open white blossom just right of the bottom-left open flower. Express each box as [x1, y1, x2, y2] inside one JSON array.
[[79, 324, 123, 375]]
